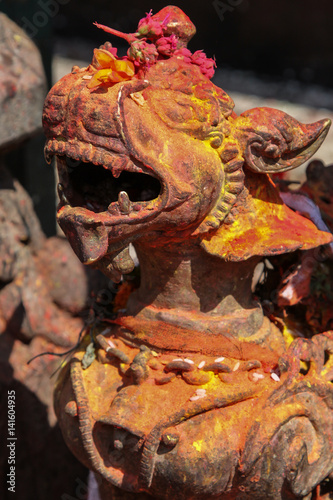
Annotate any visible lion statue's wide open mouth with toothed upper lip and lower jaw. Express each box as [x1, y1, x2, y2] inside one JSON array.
[[45, 139, 169, 281]]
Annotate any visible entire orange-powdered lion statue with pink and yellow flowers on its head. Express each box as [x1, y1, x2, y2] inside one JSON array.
[[44, 7, 333, 500]]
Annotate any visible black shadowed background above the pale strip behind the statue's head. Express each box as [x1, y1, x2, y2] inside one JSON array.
[[0, 0, 333, 86]]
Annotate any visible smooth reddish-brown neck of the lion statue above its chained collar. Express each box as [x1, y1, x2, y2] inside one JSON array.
[[127, 245, 263, 337]]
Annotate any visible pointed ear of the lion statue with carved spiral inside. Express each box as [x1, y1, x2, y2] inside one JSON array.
[[235, 108, 331, 173]]
